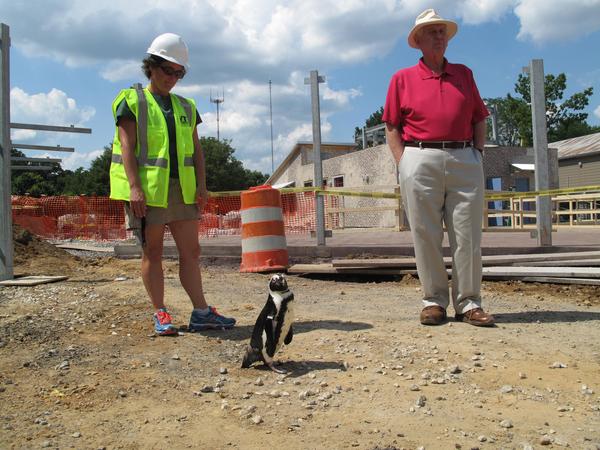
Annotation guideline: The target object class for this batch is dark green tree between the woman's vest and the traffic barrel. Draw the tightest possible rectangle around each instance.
[200,137,268,192]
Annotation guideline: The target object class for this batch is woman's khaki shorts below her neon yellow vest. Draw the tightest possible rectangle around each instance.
[125,178,200,245]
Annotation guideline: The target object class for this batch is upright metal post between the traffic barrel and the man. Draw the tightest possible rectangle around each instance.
[304,70,325,246]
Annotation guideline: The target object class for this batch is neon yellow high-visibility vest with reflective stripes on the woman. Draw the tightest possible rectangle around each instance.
[110,84,196,208]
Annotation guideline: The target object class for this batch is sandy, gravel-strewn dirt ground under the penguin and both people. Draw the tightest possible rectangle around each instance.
[0,229,600,450]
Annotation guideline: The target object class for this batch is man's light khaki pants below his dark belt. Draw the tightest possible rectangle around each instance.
[399,147,484,314]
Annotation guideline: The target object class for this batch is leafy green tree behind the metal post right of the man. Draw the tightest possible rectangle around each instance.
[485,73,600,146]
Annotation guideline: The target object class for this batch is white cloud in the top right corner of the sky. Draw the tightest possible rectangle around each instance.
[515,0,600,44]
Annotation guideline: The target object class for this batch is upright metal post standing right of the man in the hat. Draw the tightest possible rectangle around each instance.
[529,59,552,247]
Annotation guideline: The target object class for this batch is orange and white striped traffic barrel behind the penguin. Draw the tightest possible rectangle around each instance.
[240,185,288,272]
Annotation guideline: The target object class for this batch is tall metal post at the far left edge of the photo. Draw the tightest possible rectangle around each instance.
[0,24,13,280]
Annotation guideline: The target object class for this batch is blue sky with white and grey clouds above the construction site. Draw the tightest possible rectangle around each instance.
[0,0,600,173]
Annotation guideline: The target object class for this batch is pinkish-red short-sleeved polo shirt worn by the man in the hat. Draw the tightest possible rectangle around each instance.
[383,58,489,141]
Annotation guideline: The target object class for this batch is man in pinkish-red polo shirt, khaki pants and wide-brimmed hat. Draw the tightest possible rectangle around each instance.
[383,9,494,326]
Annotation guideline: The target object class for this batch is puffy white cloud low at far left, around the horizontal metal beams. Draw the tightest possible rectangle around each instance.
[10,87,96,140]
